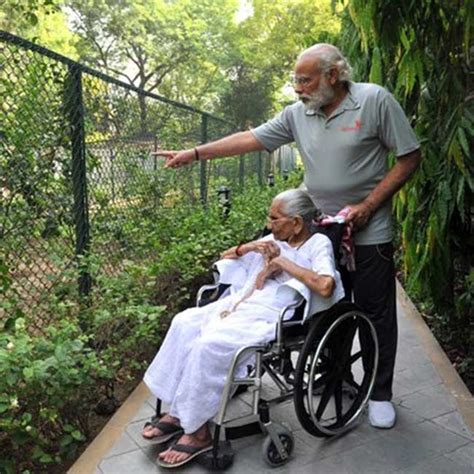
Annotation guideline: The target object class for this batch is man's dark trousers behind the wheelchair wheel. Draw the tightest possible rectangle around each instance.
[341,242,398,401]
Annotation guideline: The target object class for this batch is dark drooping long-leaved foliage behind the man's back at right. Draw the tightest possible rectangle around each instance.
[341,0,474,380]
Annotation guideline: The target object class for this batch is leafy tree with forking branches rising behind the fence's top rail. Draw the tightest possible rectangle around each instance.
[68,0,236,132]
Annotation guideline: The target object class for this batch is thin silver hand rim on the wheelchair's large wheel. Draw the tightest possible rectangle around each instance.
[307,311,378,436]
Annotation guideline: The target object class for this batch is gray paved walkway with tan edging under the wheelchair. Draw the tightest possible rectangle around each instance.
[70,284,474,474]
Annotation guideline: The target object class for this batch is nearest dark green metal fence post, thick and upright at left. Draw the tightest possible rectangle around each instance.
[65,65,91,296]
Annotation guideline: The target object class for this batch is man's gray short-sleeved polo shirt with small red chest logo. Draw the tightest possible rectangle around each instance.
[252,83,420,245]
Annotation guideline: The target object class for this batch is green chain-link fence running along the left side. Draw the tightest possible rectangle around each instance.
[0,32,295,328]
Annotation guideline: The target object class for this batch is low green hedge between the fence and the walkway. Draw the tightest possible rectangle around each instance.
[0,168,300,473]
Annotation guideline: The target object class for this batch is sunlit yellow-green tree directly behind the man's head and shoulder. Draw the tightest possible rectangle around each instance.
[221,0,340,127]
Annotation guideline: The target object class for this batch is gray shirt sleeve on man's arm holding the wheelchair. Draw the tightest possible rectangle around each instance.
[378,91,420,156]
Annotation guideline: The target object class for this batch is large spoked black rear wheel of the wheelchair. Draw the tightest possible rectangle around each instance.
[294,303,378,436]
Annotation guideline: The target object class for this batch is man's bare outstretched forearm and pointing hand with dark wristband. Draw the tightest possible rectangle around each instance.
[153,131,265,168]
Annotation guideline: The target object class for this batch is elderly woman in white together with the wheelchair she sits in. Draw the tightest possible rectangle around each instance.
[142,189,376,468]
